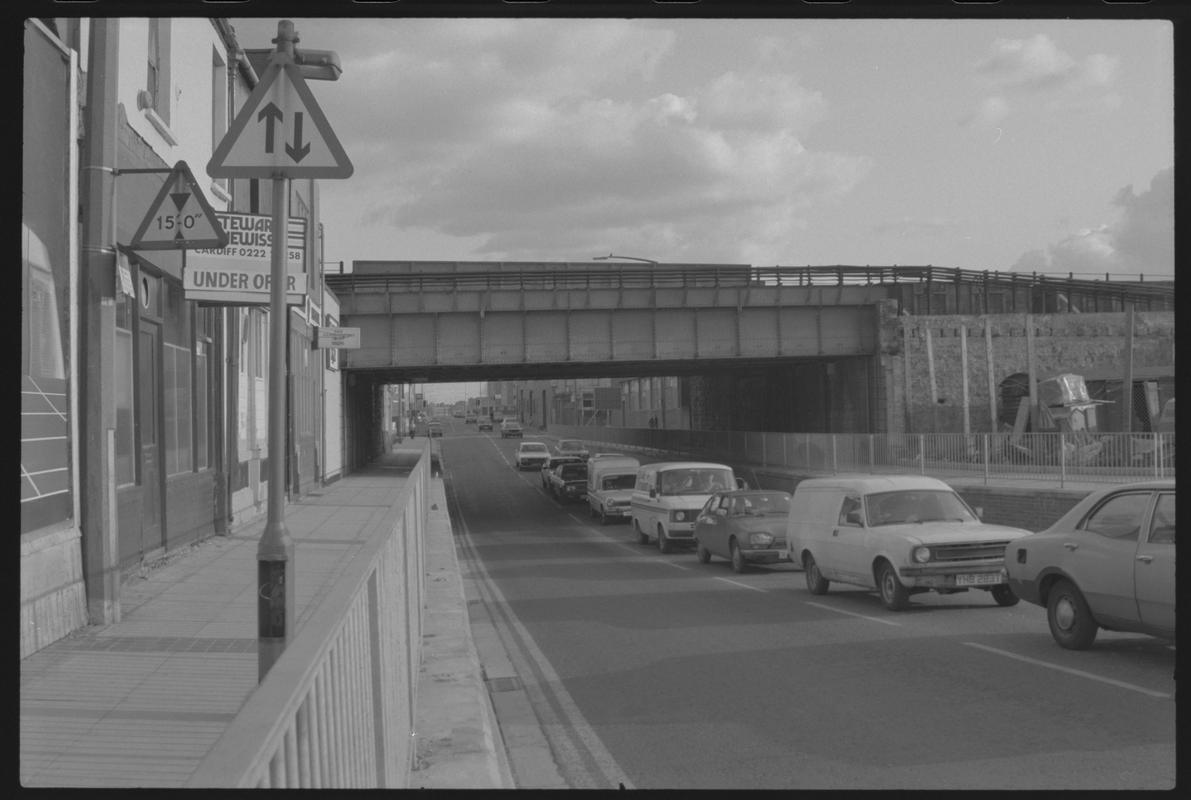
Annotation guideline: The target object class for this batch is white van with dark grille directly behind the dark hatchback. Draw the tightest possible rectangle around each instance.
[631,461,743,552]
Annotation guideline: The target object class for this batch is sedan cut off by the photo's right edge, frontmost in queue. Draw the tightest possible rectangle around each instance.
[1005,479,1176,650]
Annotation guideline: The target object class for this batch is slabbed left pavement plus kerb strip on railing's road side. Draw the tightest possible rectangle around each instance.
[19,442,516,789]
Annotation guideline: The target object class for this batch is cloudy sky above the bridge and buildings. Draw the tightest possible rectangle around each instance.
[231,17,1174,277]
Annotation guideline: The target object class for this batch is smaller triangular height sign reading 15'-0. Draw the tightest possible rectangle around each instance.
[131,161,227,250]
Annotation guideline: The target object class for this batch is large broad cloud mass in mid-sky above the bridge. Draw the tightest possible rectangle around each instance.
[326,20,871,262]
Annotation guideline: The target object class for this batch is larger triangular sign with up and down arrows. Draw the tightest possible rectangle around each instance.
[207,52,354,177]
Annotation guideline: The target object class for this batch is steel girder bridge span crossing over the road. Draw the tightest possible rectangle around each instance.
[324,261,890,463]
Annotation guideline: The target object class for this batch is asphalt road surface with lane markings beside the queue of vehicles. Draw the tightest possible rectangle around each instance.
[442,420,1176,789]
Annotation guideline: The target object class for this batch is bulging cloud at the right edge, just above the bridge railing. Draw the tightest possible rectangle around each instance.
[1012,167,1174,275]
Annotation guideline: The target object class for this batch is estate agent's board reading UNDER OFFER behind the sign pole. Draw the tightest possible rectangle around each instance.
[182,211,306,306]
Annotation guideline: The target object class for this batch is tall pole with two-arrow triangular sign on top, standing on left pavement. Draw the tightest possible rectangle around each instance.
[207,19,353,681]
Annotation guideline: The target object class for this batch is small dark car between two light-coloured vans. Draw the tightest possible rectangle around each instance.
[694,489,790,573]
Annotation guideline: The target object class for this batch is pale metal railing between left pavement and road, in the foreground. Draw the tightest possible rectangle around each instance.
[187,448,430,788]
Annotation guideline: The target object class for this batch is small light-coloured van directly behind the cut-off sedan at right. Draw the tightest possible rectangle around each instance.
[786,475,1030,611]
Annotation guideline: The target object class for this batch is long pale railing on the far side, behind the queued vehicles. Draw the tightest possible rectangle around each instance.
[550,425,1174,488]
